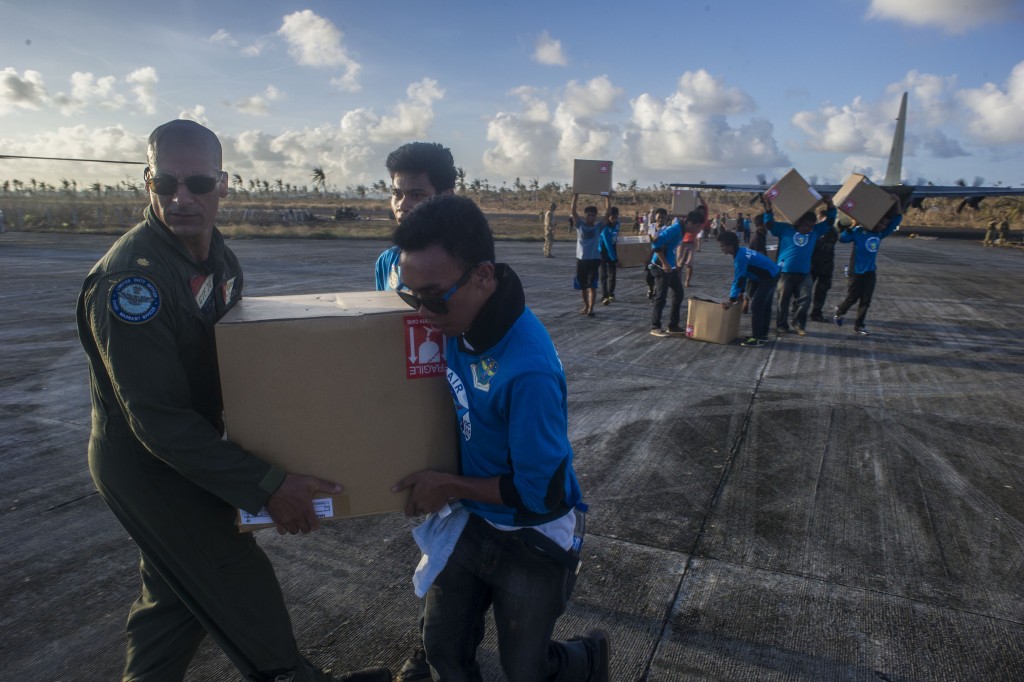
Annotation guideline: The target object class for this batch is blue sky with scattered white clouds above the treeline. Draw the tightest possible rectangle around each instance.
[0,0,1024,187]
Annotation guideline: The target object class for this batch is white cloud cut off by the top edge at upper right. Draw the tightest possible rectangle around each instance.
[867,0,1021,33]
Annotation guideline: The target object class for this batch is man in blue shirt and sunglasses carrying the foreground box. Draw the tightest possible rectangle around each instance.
[393,197,609,682]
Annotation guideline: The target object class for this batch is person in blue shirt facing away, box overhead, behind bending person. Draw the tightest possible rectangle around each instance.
[764,197,836,336]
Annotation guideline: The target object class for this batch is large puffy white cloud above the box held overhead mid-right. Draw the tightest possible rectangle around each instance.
[624,70,788,170]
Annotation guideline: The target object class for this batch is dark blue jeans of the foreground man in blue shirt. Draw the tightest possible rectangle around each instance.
[423,514,596,682]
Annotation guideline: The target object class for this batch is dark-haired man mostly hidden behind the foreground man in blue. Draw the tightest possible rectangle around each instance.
[374,142,458,291]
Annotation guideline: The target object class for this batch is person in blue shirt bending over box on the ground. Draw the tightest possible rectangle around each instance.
[718,231,779,348]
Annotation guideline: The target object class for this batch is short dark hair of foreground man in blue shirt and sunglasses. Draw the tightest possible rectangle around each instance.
[391,195,495,267]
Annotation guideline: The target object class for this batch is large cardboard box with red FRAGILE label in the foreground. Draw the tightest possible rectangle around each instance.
[215,292,458,516]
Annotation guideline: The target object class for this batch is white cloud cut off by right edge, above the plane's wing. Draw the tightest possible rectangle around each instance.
[956,61,1024,144]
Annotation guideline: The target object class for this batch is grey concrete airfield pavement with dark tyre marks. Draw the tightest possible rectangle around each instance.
[0,232,1024,682]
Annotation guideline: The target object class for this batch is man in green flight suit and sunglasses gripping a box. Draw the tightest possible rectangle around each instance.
[77,120,391,682]
